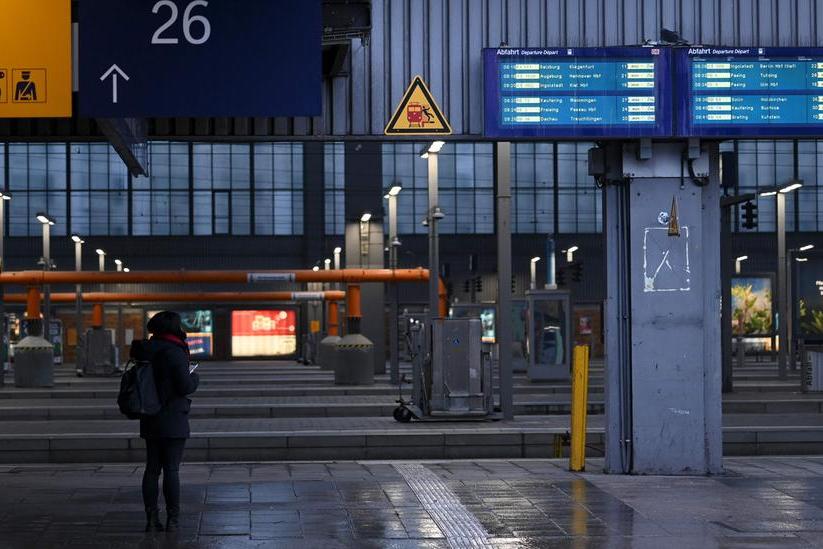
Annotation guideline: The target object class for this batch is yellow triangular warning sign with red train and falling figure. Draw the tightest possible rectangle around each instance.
[385,76,452,135]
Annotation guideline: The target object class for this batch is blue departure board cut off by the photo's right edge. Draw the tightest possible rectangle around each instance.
[675,47,823,137]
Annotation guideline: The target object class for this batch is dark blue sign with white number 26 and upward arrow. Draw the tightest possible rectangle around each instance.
[78,0,322,118]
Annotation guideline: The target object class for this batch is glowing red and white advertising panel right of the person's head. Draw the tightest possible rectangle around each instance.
[231,310,297,358]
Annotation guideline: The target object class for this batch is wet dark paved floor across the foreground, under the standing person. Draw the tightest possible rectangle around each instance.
[0,457,823,549]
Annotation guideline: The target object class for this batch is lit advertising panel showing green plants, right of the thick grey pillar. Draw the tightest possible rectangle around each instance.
[732,276,774,336]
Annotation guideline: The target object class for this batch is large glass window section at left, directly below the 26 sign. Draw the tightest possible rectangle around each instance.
[0,141,303,236]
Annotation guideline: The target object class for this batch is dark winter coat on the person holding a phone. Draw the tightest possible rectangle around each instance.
[140,338,200,438]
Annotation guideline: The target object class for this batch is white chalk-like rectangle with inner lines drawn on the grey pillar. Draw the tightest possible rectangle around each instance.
[643,227,691,292]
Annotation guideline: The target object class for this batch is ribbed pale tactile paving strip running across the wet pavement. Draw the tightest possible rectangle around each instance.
[394,463,494,549]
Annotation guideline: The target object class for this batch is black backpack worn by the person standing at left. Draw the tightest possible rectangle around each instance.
[117,339,163,419]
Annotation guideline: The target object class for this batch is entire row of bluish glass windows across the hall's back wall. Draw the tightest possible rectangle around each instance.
[0,140,823,236]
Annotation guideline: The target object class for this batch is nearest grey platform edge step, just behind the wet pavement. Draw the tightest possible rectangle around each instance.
[0,416,823,463]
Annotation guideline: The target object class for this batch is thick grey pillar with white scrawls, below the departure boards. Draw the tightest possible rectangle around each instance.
[604,143,722,474]
